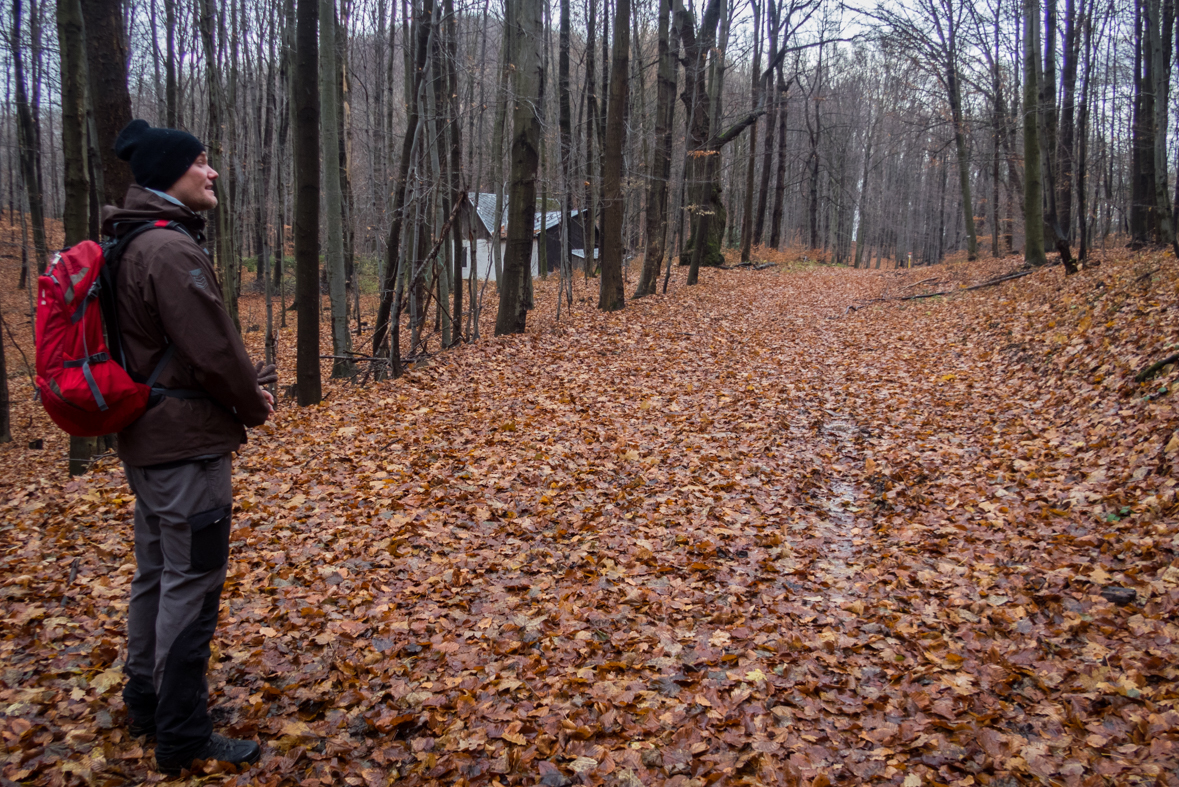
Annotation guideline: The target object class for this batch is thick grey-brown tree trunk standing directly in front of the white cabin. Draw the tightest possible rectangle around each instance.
[495,0,544,336]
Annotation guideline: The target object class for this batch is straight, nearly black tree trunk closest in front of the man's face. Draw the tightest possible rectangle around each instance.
[292,0,323,406]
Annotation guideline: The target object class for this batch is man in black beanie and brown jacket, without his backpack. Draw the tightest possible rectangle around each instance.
[103,120,277,773]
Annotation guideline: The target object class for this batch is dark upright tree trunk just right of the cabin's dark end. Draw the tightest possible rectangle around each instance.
[603,0,631,311]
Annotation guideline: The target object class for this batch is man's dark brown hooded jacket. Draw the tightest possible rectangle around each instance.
[103,185,268,467]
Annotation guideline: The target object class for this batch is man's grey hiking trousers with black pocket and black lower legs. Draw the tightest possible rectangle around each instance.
[123,454,233,761]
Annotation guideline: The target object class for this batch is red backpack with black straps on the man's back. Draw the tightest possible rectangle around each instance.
[37,220,187,437]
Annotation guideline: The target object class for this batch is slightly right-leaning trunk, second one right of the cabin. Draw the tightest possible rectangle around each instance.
[634,0,676,298]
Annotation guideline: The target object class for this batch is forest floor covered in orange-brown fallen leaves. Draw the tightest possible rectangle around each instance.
[0,241,1179,787]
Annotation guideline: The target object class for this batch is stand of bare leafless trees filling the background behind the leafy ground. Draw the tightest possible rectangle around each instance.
[9,0,1179,464]
